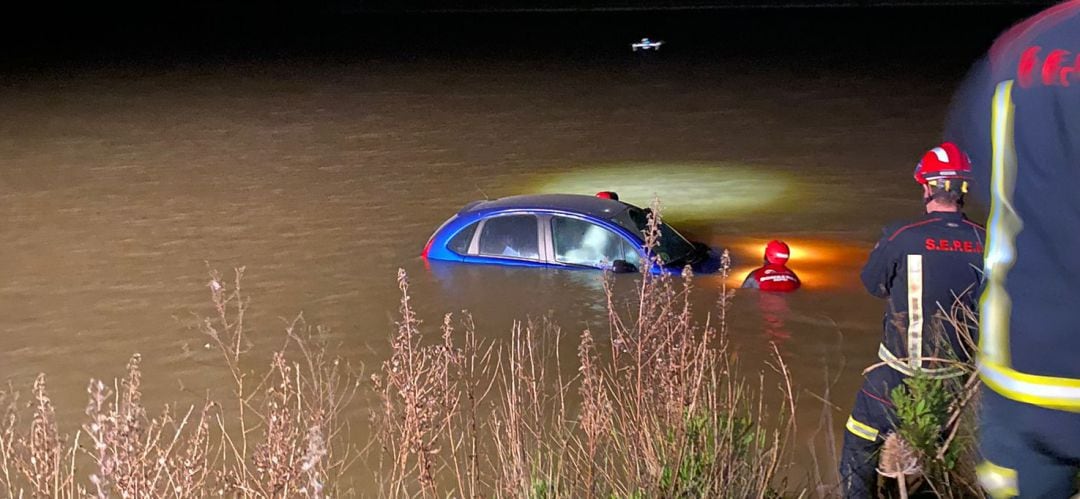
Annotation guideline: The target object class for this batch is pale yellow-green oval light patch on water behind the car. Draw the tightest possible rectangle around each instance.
[535,163,791,221]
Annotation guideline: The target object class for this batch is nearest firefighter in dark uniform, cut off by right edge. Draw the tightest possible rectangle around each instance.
[946,0,1080,498]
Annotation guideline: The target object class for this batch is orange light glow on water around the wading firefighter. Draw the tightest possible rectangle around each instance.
[714,235,870,289]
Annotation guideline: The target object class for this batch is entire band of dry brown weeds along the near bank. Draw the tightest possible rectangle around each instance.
[0,204,812,499]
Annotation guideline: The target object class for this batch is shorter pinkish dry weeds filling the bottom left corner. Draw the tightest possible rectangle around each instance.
[0,268,360,498]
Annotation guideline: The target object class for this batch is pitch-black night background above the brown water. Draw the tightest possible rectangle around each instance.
[0,0,1047,69]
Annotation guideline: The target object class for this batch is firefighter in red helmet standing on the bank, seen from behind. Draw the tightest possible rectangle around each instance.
[840,143,986,498]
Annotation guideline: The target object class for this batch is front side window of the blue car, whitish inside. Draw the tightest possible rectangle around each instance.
[551,217,638,268]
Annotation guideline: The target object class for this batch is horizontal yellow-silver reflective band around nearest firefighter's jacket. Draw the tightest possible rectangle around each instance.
[978,359,1080,413]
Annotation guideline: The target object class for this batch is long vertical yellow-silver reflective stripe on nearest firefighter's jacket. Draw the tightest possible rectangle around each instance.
[978,80,1023,365]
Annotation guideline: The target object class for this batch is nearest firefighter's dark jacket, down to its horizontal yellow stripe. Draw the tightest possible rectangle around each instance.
[950,1,1080,401]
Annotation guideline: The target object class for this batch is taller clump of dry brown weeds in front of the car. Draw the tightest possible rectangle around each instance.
[373,205,795,498]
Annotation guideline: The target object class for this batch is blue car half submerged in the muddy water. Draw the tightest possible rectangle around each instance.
[423,194,719,273]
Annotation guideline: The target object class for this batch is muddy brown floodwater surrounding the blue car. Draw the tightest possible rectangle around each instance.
[0,54,984,488]
